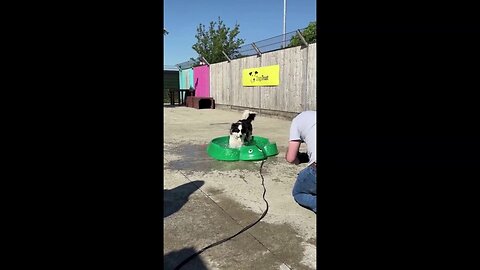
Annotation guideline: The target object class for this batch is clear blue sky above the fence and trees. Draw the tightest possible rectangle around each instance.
[163,0,317,65]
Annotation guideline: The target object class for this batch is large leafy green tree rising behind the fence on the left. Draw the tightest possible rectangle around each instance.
[192,17,244,64]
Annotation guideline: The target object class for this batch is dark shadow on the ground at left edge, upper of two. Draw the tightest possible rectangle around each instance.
[163,180,205,218]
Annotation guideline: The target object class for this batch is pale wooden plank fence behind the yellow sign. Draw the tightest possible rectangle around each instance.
[210,43,317,113]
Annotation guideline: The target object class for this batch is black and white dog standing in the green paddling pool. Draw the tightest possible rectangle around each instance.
[228,110,257,148]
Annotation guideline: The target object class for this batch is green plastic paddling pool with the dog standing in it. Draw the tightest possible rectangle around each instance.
[207,136,278,161]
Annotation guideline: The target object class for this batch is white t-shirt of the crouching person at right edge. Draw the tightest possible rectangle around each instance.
[290,111,317,165]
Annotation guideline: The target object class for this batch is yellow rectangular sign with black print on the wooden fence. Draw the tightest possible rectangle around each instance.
[242,65,280,86]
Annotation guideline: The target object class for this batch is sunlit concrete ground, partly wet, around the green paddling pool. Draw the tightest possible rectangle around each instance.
[163,107,317,270]
